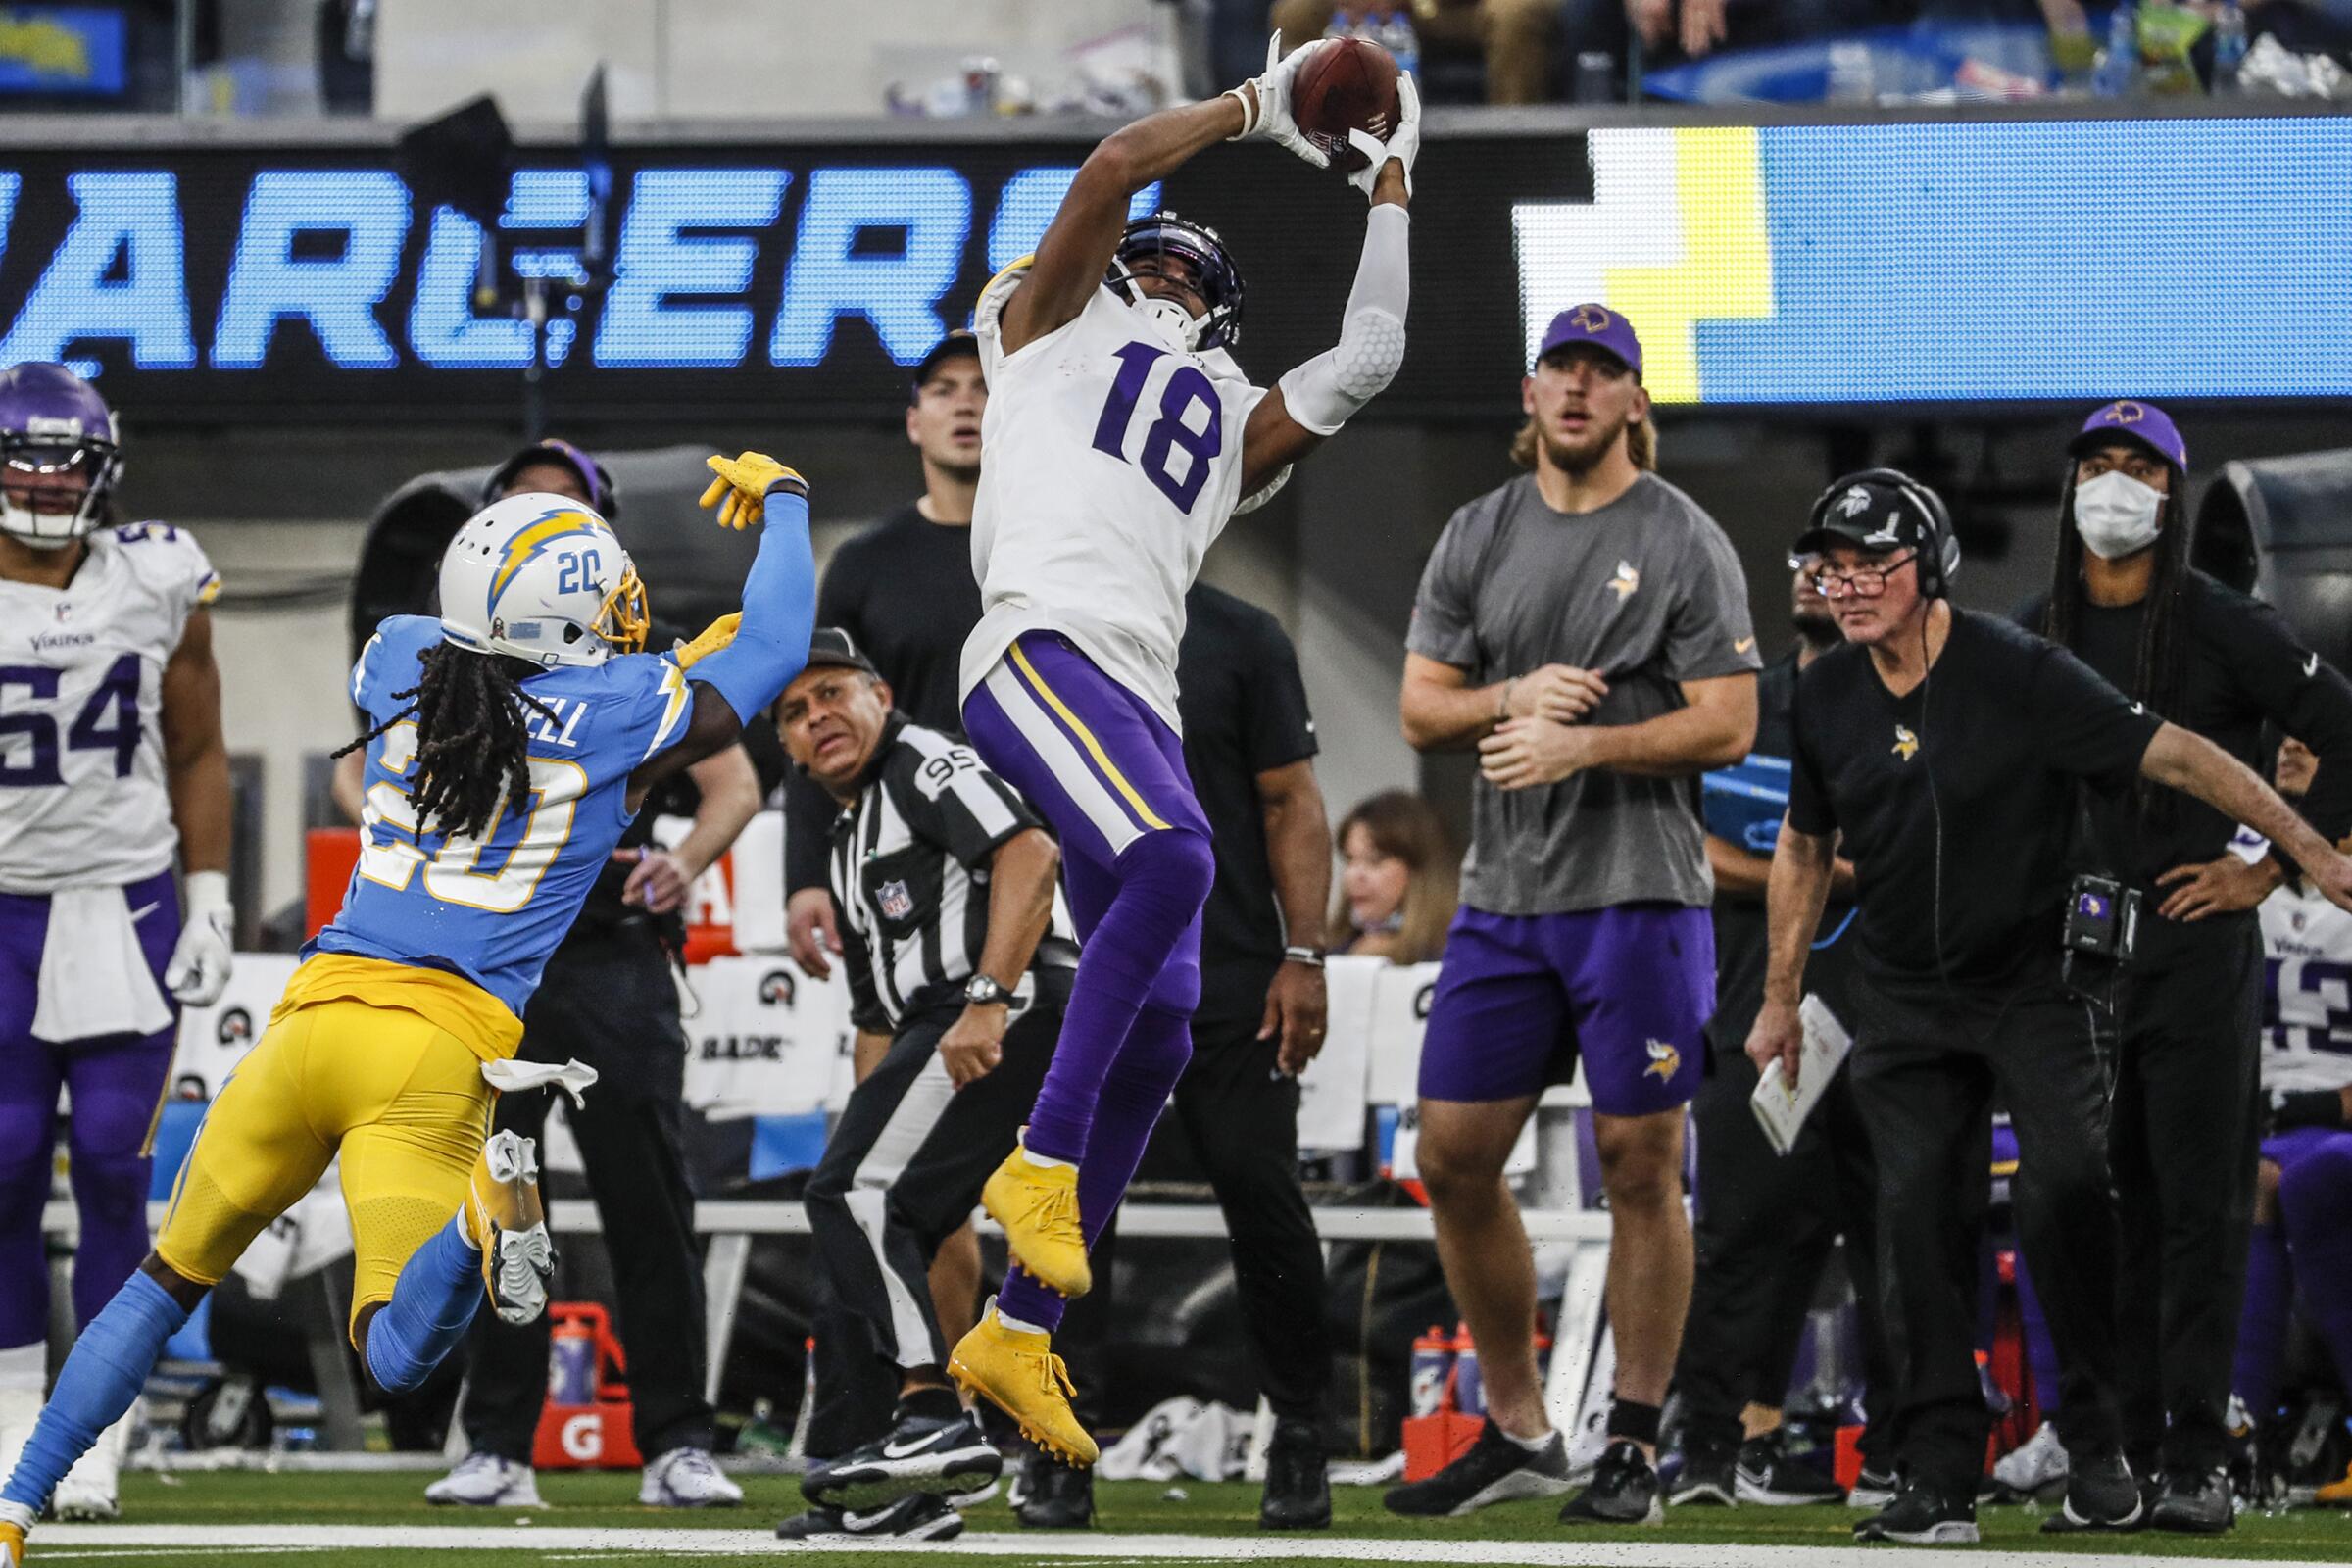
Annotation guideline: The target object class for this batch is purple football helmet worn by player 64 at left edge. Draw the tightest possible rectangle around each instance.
[0,360,122,550]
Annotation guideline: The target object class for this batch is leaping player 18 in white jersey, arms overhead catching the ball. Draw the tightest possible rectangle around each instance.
[951,42,1421,1464]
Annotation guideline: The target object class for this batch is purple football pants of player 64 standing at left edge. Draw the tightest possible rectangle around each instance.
[0,872,178,1349]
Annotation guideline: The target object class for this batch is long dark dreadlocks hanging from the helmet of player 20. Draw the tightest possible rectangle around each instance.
[336,642,555,839]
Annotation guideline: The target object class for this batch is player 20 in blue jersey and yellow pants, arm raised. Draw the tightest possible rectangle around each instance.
[0,454,816,1568]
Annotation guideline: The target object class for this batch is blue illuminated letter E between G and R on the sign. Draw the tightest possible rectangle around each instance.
[595,170,790,367]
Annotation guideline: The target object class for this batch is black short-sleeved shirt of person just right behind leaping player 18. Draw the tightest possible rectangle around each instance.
[1176,583,1317,1022]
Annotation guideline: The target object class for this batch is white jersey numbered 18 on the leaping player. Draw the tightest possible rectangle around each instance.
[962,270,1265,731]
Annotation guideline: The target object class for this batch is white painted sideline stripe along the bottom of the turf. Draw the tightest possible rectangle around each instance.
[35,1523,2319,1568]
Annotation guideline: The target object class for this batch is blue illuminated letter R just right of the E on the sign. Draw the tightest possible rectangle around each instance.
[766,170,971,365]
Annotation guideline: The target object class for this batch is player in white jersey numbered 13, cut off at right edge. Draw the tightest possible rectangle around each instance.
[2232,741,2352,1504]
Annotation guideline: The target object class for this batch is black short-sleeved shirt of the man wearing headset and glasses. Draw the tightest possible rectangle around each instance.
[1788,609,2164,987]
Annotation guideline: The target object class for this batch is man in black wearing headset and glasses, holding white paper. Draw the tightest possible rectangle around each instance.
[1747,467,2352,1544]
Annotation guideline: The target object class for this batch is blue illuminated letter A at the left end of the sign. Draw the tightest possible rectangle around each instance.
[0,174,195,369]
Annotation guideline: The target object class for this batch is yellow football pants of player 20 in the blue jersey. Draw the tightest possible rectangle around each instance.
[155,1002,496,1343]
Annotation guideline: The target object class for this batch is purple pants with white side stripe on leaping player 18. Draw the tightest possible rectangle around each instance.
[964,632,1216,1328]
